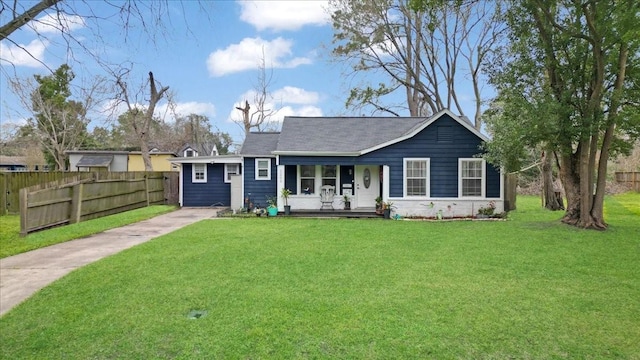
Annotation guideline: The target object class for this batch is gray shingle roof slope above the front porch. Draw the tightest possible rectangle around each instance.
[274,117,428,153]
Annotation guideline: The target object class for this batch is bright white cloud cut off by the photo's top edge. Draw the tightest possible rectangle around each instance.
[238,0,330,31]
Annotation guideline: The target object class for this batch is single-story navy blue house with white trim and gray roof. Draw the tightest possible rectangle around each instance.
[172,110,504,216]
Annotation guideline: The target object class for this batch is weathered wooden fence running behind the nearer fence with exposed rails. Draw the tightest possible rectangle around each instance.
[0,171,179,216]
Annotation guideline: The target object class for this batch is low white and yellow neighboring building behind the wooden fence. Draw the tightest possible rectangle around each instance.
[66,150,178,172]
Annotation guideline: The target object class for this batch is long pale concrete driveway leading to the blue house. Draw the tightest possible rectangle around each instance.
[0,208,217,315]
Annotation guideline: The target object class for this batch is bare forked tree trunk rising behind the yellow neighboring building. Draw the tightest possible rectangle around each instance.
[116,71,169,171]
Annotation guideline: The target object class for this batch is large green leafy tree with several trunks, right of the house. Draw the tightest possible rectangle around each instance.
[490,0,640,229]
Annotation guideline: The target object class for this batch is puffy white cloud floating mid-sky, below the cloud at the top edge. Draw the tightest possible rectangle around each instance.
[207,37,311,76]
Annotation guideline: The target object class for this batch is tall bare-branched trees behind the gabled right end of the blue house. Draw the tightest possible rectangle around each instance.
[331,0,502,128]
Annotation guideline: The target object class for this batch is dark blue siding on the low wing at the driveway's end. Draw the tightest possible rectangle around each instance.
[182,164,231,206]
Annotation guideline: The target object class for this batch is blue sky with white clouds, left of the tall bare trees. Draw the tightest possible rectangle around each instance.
[0,1,480,148]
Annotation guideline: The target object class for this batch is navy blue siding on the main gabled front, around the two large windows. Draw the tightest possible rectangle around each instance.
[280,115,500,198]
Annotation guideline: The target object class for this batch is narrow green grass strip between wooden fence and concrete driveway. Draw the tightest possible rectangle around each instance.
[0,205,176,259]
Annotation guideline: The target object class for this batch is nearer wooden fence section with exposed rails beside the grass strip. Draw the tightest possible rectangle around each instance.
[20,173,176,235]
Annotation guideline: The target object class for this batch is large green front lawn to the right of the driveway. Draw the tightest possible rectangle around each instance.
[0,194,640,359]
